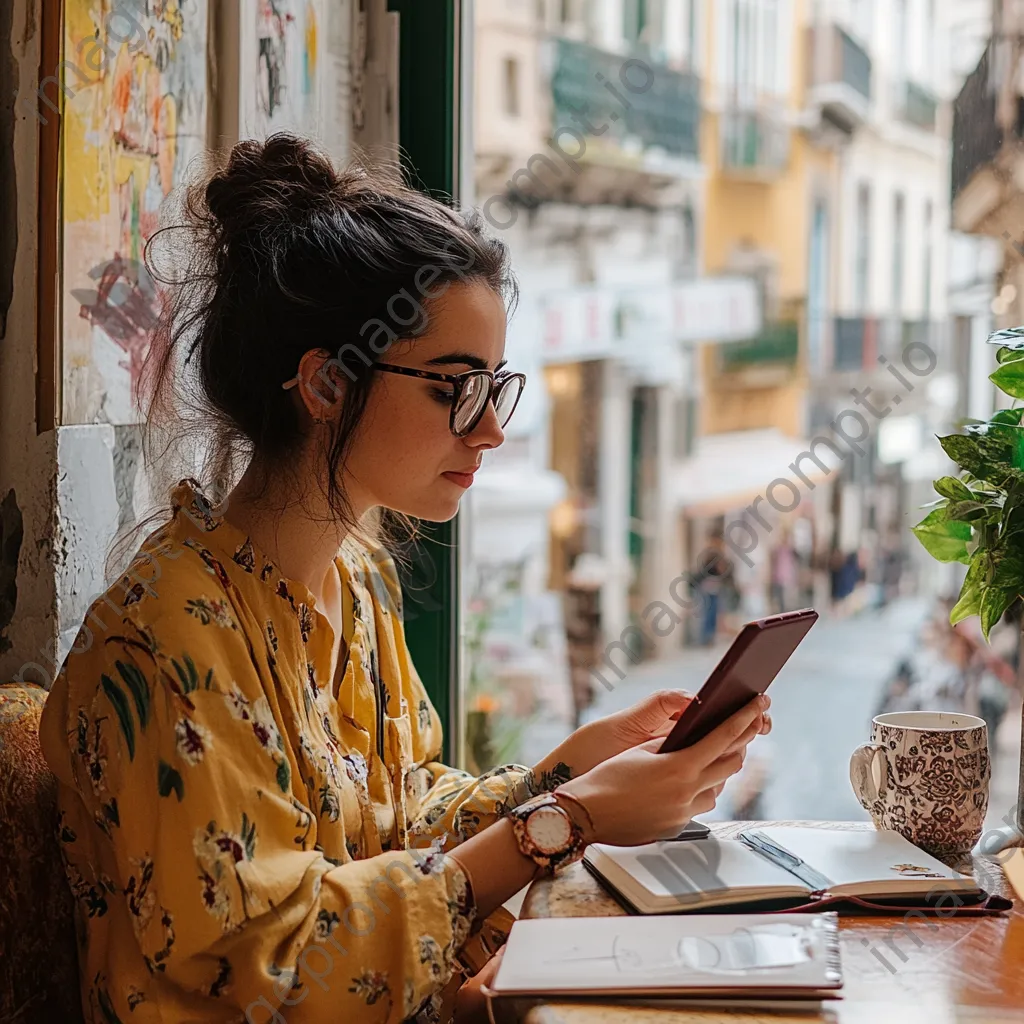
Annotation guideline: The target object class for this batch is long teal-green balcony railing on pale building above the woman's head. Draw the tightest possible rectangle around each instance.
[551,39,700,160]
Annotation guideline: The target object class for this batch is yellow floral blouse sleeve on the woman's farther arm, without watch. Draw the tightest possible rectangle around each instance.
[364,549,569,850]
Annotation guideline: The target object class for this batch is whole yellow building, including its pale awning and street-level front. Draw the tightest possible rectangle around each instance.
[677,0,847,622]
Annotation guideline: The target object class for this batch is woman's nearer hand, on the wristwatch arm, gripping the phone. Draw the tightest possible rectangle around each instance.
[555,696,771,846]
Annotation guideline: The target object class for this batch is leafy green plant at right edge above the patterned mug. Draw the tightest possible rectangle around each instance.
[913,327,1024,852]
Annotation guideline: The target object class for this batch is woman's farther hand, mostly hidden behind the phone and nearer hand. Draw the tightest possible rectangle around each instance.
[534,690,693,778]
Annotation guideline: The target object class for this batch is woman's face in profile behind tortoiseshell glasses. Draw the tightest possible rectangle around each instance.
[337,282,506,522]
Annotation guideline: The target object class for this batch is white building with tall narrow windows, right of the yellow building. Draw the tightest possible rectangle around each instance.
[813,0,966,581]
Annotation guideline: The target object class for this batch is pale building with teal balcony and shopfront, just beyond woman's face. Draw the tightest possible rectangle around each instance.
[466,0,760,737]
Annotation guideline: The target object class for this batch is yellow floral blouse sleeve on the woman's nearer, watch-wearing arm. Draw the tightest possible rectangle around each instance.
[47,606,475,1024]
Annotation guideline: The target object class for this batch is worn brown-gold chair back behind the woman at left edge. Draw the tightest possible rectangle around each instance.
[0,683,84,1024]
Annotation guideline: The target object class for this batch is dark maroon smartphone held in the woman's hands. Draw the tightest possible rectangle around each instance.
[657,608,818,754]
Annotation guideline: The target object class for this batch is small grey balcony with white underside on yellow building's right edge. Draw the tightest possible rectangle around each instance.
[807,23,871,132]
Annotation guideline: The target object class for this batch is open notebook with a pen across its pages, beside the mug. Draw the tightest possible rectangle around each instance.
[584,825,983,913]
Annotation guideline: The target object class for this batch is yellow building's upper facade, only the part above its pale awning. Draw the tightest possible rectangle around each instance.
[700,0,838,438]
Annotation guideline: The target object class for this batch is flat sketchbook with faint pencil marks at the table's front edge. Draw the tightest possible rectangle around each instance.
[490,913,843,1008]
